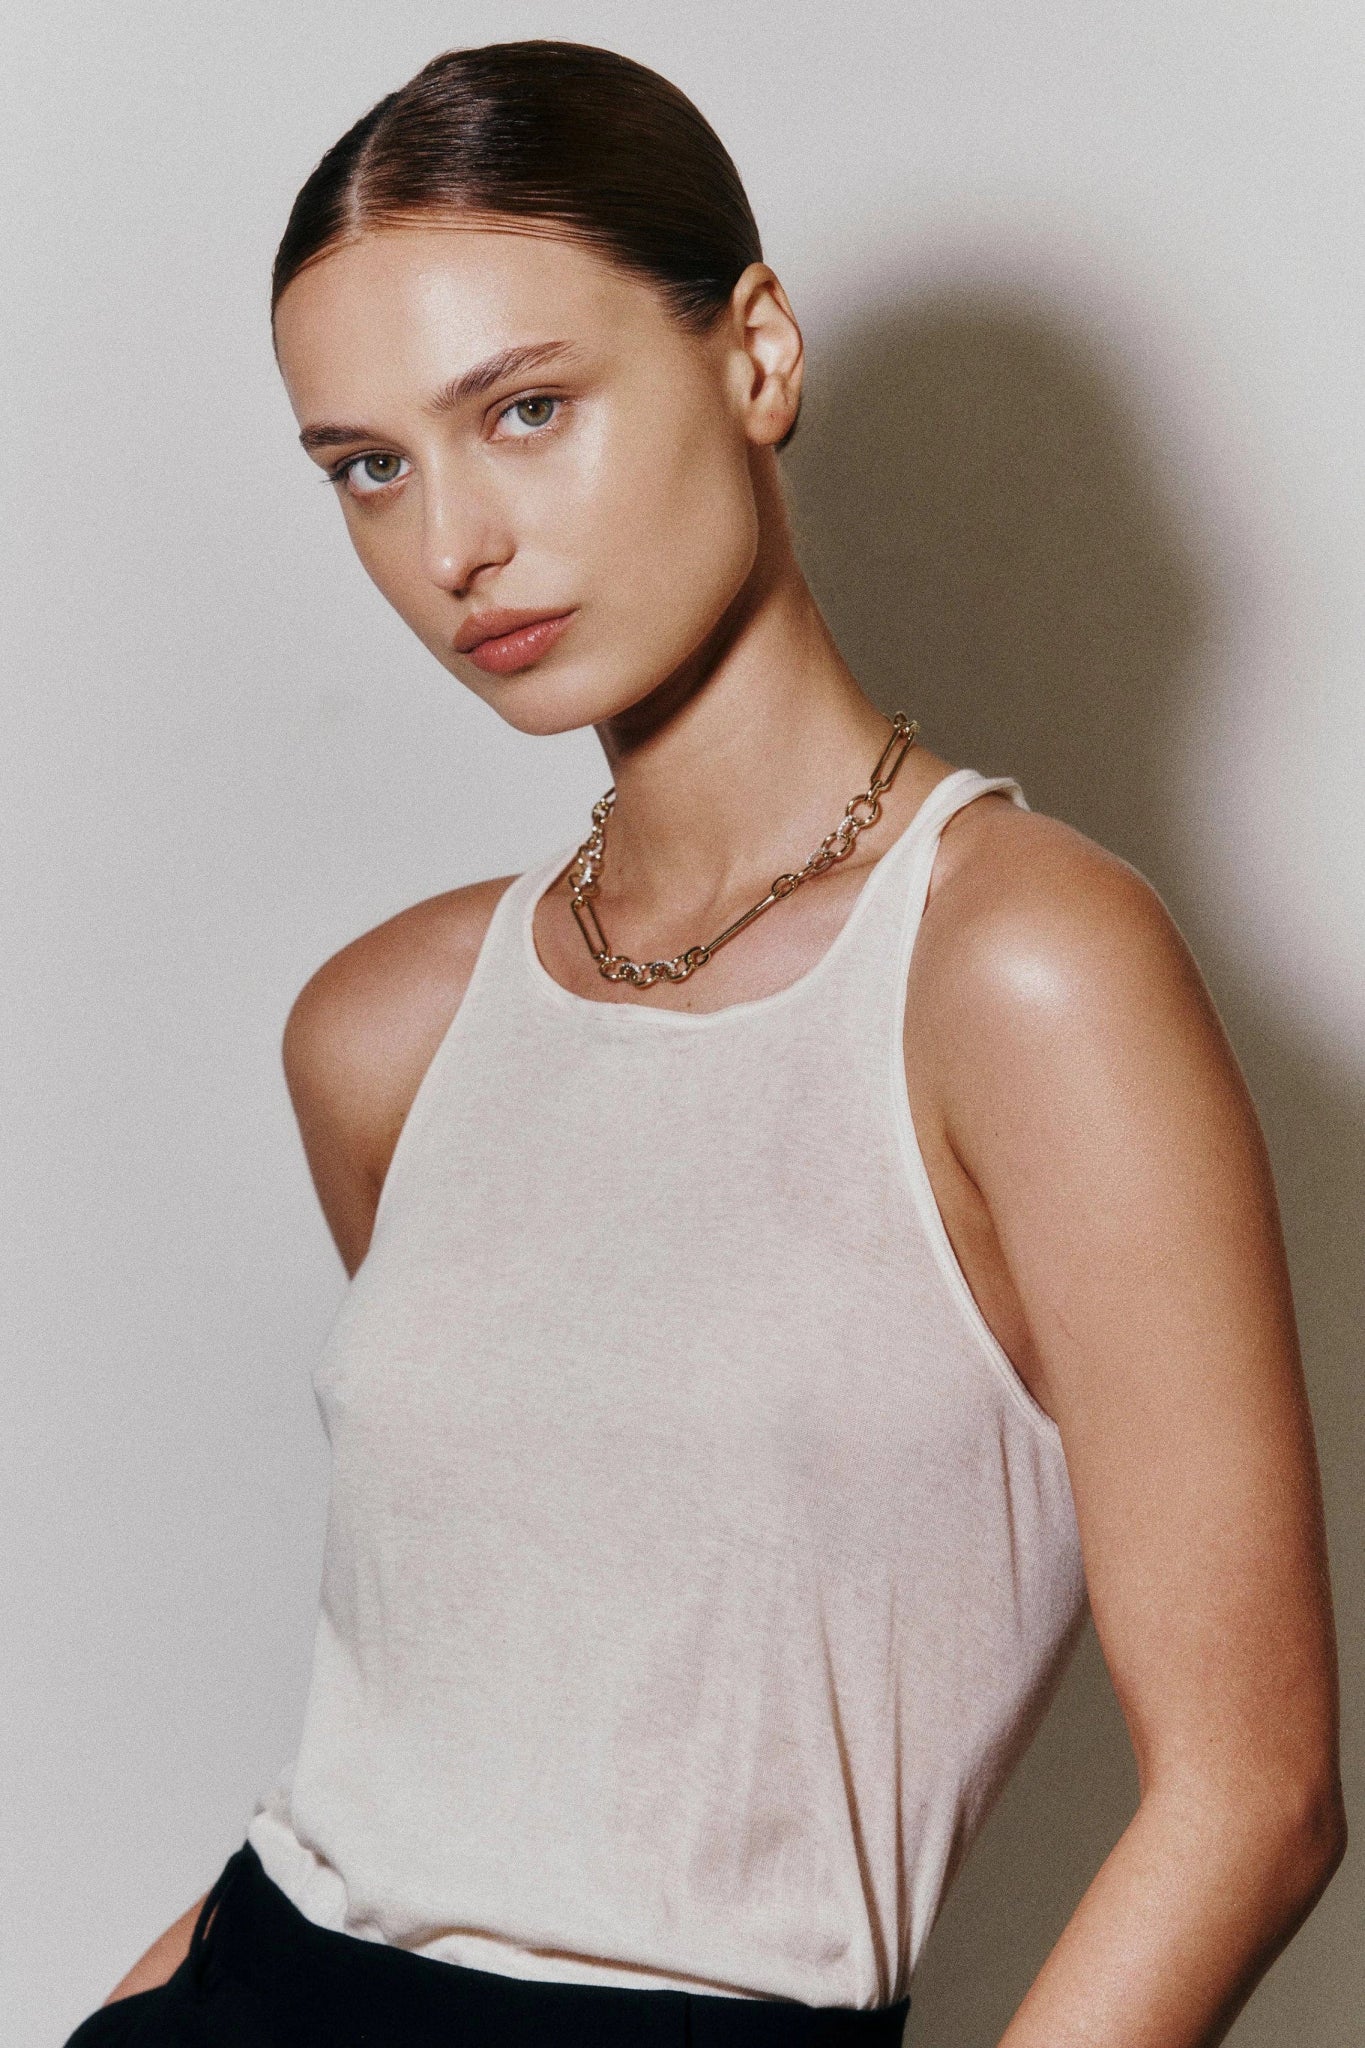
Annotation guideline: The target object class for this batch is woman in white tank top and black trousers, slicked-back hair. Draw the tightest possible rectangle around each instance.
[74,43,1342,2048]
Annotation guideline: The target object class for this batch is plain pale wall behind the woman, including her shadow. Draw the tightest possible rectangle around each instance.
[0,0,1365,2048]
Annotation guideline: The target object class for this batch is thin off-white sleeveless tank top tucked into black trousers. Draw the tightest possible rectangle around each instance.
[248,768,1085,2007]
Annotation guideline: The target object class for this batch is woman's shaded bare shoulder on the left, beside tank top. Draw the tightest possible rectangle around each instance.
[284,877,510,1274]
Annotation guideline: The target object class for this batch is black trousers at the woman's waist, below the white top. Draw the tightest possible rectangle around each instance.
[68,1843,911,2048]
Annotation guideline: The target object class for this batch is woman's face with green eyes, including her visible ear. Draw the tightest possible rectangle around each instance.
[274,223,800,733]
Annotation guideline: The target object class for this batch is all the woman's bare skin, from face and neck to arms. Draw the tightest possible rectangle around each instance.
[104,219,1345,2048]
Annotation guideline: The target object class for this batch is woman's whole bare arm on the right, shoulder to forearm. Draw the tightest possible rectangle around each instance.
[915,805,1345,2048]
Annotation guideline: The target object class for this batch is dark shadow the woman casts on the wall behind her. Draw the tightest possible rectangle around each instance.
[786,293,1365,2048]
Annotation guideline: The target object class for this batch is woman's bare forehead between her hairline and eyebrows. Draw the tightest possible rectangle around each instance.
[274,223,673,410]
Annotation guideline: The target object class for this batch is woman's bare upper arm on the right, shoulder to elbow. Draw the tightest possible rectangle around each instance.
[925,813,1336,1826]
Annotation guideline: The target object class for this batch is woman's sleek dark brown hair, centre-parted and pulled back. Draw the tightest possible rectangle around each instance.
[270,41,763,332]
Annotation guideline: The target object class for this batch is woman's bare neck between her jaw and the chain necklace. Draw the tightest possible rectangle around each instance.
[598,477,913,907]
